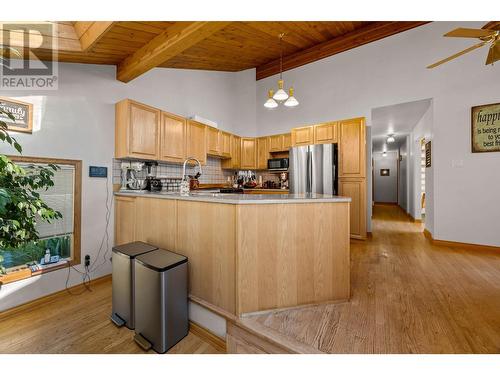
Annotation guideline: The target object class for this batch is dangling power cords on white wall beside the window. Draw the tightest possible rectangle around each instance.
[66,174,113,295]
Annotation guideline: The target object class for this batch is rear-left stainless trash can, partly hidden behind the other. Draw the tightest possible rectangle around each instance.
[111,241,158,329]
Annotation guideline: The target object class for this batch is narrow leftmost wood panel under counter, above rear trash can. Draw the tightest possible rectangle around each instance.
[115,196,136,246]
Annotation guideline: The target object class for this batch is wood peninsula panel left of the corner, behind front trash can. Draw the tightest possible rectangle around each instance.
[175,201,236,314]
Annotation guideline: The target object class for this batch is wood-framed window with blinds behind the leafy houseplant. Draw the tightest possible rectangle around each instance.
[0,156,81,282]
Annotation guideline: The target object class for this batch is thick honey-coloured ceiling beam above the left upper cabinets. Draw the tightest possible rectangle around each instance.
[116,21,231,82]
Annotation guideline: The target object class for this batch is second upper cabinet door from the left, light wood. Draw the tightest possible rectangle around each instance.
[160,112,186,163]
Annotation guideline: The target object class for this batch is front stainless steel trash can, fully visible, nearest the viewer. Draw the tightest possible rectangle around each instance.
[134,249,189,353]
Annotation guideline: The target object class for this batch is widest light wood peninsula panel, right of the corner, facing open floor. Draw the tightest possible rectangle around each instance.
[236,203,350,315]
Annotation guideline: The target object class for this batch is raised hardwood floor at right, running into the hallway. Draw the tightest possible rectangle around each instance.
[241,205,500,353]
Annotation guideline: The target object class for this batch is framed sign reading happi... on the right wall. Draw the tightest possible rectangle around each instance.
[471,103,500,152]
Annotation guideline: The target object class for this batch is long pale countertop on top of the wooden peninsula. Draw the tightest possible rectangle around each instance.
[115,190,351,204]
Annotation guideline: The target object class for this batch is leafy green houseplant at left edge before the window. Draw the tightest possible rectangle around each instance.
[0,109,62,273]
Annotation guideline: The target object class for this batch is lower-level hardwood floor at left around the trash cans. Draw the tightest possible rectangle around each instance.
[0,280,225,354]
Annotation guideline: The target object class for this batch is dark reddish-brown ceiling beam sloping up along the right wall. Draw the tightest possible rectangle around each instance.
[256,21,428,80]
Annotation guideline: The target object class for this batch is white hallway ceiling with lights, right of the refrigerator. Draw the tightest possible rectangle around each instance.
[371,99,431,152]
